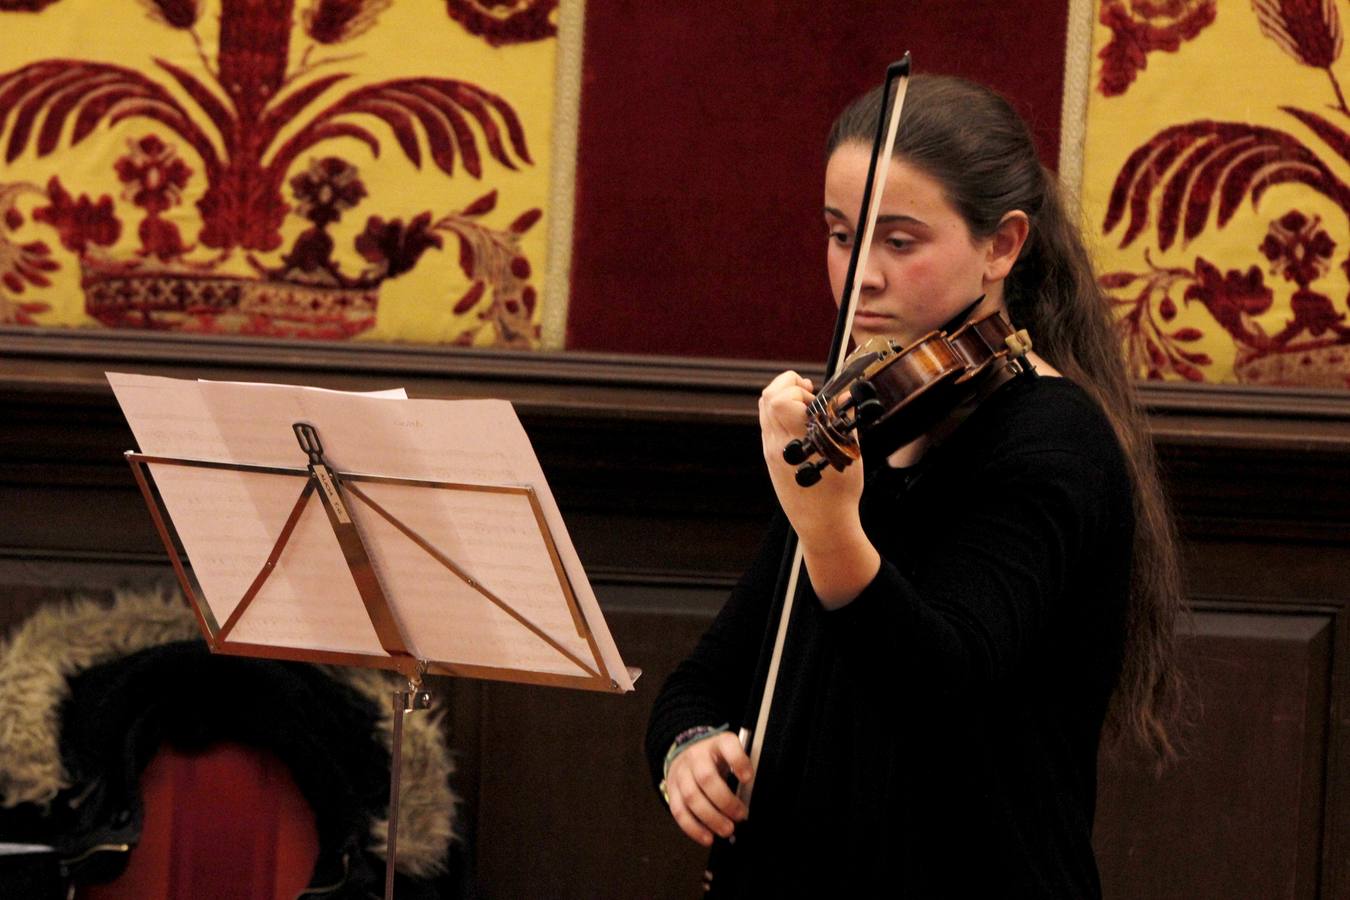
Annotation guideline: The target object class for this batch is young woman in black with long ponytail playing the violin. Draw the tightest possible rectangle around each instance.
[647,76,1180,899]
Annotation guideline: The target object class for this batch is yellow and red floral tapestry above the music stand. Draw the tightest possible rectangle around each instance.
[0,0,566,347]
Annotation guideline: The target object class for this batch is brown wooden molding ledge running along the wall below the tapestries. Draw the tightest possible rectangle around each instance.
[0,327,1350,439]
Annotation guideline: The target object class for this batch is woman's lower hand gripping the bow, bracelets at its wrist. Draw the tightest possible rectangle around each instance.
[666,731,755,847]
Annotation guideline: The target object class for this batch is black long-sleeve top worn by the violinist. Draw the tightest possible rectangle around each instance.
[647,378,1134,899]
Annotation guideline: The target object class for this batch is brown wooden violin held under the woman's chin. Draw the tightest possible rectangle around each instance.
[783,297,1033,487]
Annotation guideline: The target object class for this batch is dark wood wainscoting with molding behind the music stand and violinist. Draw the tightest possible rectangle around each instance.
[0,334,1350,900]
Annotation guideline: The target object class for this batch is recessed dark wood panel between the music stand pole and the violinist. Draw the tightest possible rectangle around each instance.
[478,599,707,900]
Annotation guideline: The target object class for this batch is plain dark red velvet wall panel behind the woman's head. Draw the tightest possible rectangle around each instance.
[567,0,1068,362]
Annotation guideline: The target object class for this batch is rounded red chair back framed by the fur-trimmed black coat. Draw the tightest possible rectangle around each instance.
[78,743,319,900]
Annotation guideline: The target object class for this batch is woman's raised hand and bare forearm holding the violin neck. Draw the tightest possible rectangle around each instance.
[759,371,880,606]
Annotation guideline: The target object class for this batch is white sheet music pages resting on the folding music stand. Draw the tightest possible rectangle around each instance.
[108,372,633,691]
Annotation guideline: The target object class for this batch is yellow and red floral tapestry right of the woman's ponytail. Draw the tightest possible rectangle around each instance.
[1083,0,1350,387]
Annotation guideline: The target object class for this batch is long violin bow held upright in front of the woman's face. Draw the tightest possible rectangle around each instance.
[703,59,910,895]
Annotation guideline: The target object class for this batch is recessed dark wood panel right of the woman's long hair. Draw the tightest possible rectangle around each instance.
[1095,610,1334,900]
